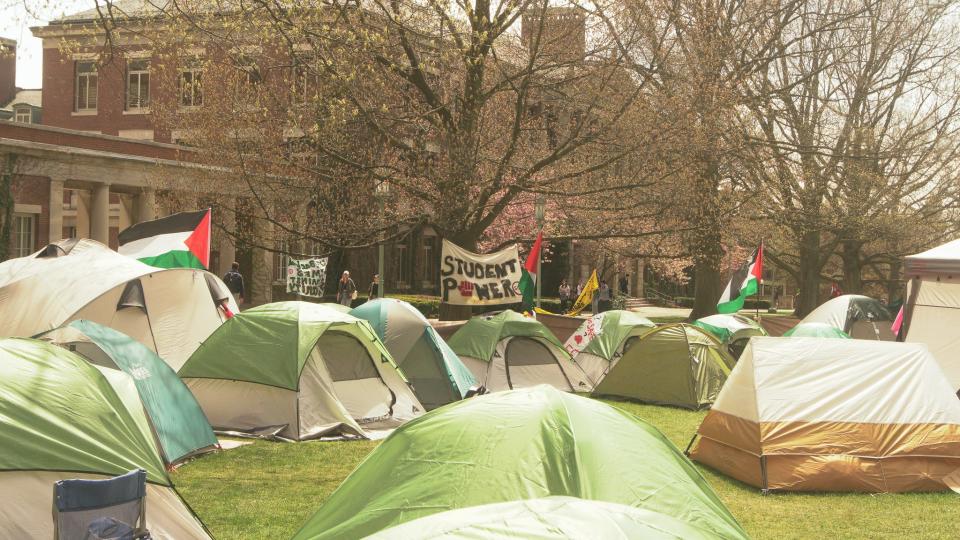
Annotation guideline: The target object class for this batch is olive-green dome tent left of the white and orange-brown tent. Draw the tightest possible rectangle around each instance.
[593,323,736,409]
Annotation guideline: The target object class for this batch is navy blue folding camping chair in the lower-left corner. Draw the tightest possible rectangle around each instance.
[53,469,150,540]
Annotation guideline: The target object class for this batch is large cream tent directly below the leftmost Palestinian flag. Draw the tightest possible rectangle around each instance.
[0,240,238,370]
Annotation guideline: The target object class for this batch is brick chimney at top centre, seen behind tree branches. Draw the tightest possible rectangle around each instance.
[520,7,587,62]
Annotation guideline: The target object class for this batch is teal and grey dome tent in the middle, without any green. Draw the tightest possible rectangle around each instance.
[350,298,477,411]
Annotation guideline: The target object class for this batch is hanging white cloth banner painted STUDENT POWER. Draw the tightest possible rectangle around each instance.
[440,240,522,305]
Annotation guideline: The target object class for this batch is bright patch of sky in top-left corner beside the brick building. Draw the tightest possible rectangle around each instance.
[0,0,89,88]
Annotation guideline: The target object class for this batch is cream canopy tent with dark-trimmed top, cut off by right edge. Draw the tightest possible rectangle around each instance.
[900,240,960,391]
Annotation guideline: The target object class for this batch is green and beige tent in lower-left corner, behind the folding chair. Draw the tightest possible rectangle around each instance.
[0,338,208,538]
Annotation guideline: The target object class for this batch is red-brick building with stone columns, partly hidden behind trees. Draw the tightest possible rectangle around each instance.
[9,0,636,308]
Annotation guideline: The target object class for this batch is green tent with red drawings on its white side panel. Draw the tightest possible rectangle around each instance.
[564,309,657,388]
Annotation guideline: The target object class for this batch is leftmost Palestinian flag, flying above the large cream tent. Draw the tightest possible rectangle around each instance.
[118,208,210,269]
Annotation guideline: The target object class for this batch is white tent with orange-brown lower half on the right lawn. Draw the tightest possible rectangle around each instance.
[690,337,960,492]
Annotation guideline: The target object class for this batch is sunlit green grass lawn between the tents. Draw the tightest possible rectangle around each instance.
[174,402,960,540]
